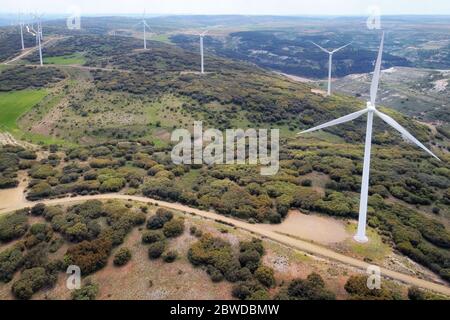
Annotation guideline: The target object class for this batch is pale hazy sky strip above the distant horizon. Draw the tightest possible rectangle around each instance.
[0,0,450,15]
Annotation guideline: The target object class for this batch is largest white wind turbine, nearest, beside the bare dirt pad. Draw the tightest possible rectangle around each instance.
[300,33,440,243]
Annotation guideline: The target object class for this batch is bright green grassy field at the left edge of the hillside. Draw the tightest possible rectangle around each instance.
[0,89,47,134]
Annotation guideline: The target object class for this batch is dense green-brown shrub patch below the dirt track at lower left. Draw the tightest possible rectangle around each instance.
[0,201,146,299]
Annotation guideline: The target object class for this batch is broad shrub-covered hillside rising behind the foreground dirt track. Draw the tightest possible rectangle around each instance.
[0,21,450,298]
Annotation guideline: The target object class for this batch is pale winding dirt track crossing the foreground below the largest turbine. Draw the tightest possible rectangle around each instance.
[0,194,450,296]
